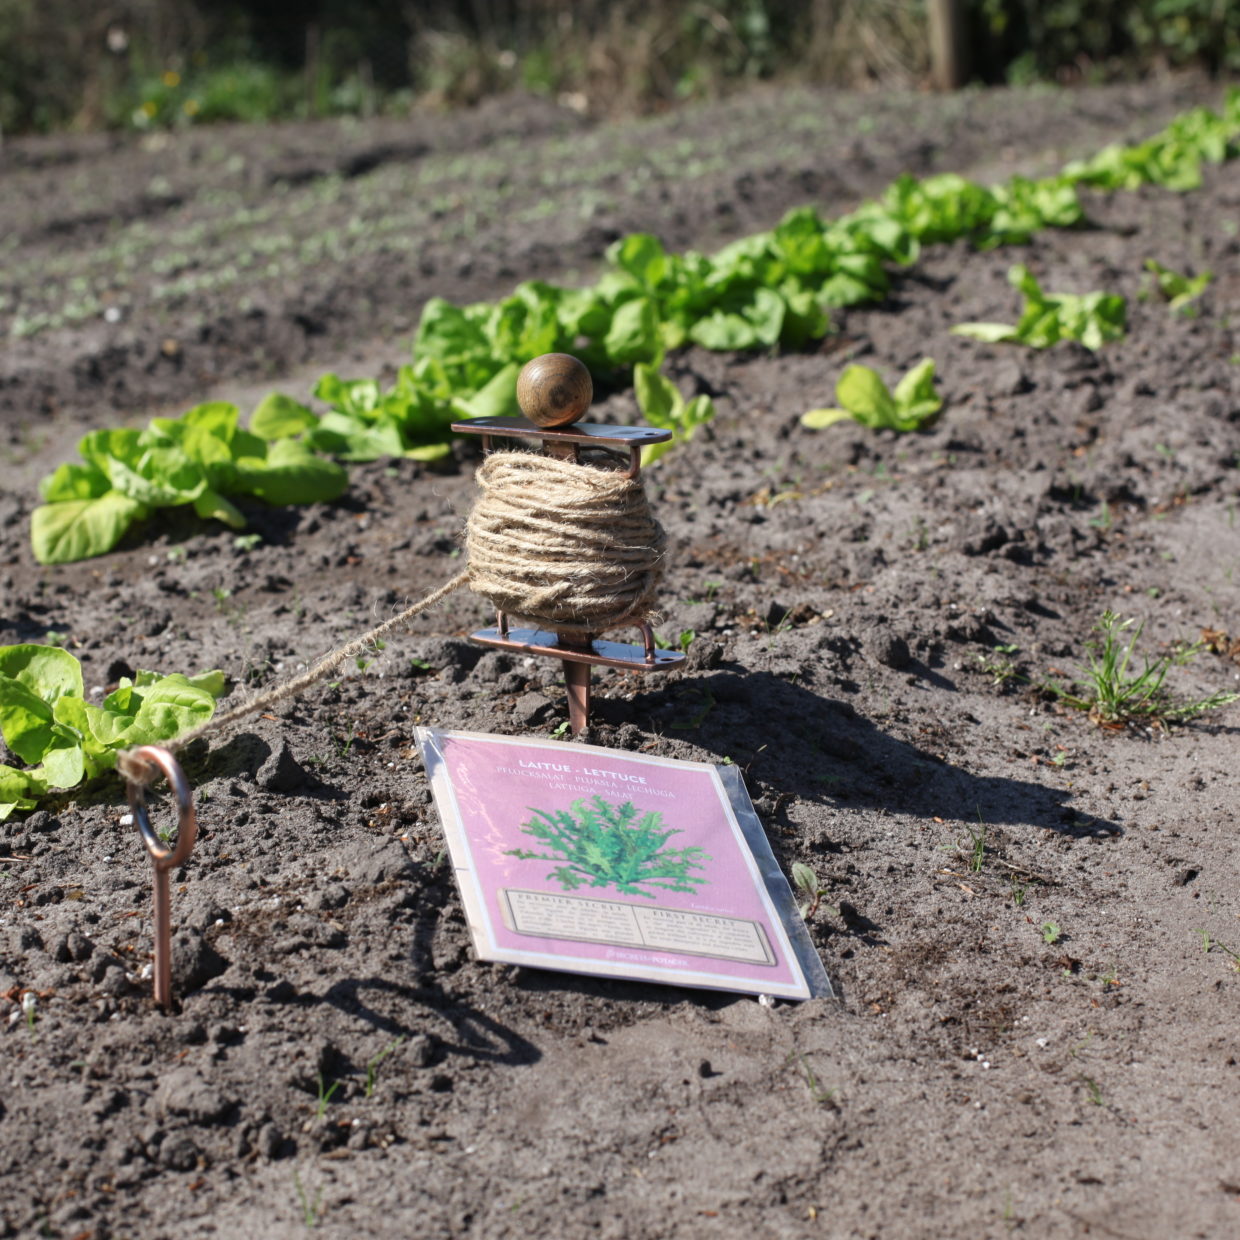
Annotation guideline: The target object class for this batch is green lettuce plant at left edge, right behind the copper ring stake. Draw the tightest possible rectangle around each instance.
[0,645,224,821]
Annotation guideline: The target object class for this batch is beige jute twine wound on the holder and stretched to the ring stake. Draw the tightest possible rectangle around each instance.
[117,451,667,785]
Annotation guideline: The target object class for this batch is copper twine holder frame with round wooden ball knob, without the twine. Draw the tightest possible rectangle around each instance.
[451,353,684,737]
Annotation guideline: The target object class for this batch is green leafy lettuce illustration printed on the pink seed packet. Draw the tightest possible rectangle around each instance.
[507,796,711,900]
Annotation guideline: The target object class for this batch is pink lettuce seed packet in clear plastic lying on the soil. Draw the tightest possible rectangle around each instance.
[415,728,831,999]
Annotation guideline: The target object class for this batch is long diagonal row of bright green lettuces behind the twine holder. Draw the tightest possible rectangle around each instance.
[31,89,1240,564]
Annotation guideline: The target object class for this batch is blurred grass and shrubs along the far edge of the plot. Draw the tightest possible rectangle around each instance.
[0,0,1240,134]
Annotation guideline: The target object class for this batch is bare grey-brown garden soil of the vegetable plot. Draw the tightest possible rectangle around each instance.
[0,79,1240,1240]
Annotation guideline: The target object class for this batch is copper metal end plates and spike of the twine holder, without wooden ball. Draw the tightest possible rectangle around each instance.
[453,418,684,737]
